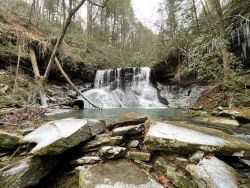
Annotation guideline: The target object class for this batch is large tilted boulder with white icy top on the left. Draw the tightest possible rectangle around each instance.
[21,118,105,155]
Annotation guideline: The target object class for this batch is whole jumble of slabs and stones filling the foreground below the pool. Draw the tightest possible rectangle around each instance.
[0,117,250,188]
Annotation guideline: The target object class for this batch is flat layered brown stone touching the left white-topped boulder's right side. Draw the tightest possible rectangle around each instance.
[80,134,125,152]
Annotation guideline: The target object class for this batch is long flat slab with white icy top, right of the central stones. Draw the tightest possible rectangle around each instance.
[144,122,250,157]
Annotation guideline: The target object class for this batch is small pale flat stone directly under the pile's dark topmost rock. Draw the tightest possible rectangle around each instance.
[112,124,144,136]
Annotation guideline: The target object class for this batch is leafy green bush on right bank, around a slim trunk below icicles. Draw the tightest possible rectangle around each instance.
[185,39,242,88]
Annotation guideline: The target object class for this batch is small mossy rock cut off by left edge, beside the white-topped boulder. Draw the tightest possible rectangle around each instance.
[0,130,22,149]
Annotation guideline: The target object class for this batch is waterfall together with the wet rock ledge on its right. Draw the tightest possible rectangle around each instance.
[80,67,211,108]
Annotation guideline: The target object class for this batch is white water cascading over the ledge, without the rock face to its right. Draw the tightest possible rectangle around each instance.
[84,67,165,108]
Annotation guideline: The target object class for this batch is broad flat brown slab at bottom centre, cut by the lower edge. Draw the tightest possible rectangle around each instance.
[78,159,163,188]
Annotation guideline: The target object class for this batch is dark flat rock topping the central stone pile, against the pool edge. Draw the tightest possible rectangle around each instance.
[107,116,147,129]
